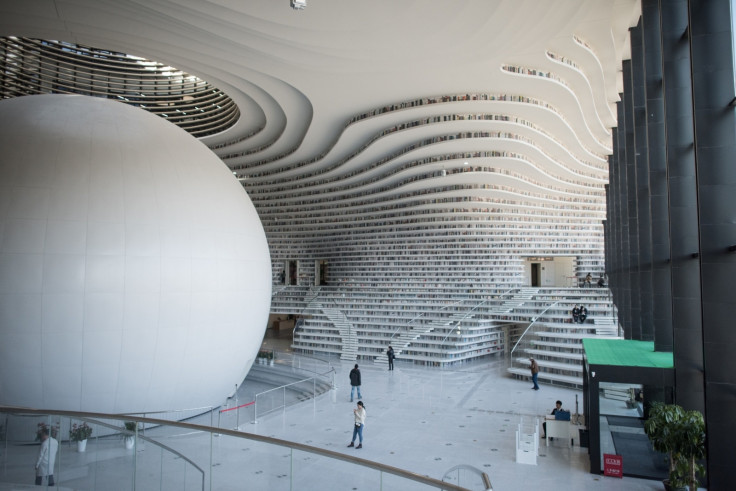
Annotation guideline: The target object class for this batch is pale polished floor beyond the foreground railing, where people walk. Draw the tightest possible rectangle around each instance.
[252,336,662,491]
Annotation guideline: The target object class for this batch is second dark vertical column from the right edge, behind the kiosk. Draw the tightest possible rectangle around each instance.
[662,0,703,409]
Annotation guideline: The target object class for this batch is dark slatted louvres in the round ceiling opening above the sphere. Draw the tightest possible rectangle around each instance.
[0,36,240,137]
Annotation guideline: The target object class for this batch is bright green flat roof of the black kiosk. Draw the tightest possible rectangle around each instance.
[583,338,675,368]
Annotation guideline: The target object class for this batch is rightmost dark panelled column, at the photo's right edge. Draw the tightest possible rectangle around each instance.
[688,0,736,489]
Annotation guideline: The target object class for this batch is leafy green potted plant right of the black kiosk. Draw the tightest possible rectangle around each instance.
[644,402,705,491]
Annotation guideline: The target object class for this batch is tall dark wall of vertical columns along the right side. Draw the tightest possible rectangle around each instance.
[605,0,736,489]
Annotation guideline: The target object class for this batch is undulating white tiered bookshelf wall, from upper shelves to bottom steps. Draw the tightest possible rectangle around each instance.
[250,53,616,372]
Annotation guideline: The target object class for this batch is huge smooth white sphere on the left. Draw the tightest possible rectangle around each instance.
[0,95,271,413]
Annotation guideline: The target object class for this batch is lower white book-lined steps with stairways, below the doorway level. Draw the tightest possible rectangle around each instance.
[272,286,617,372]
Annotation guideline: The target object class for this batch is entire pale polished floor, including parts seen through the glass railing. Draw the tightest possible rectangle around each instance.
[0,333,662,491]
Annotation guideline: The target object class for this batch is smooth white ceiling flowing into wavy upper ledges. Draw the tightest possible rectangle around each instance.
[0,0,640,254]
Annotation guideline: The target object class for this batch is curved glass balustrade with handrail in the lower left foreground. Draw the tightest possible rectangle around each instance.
[0,406,467,491]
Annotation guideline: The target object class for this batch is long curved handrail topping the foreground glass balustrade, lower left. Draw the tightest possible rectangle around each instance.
[0,406,470,491]
